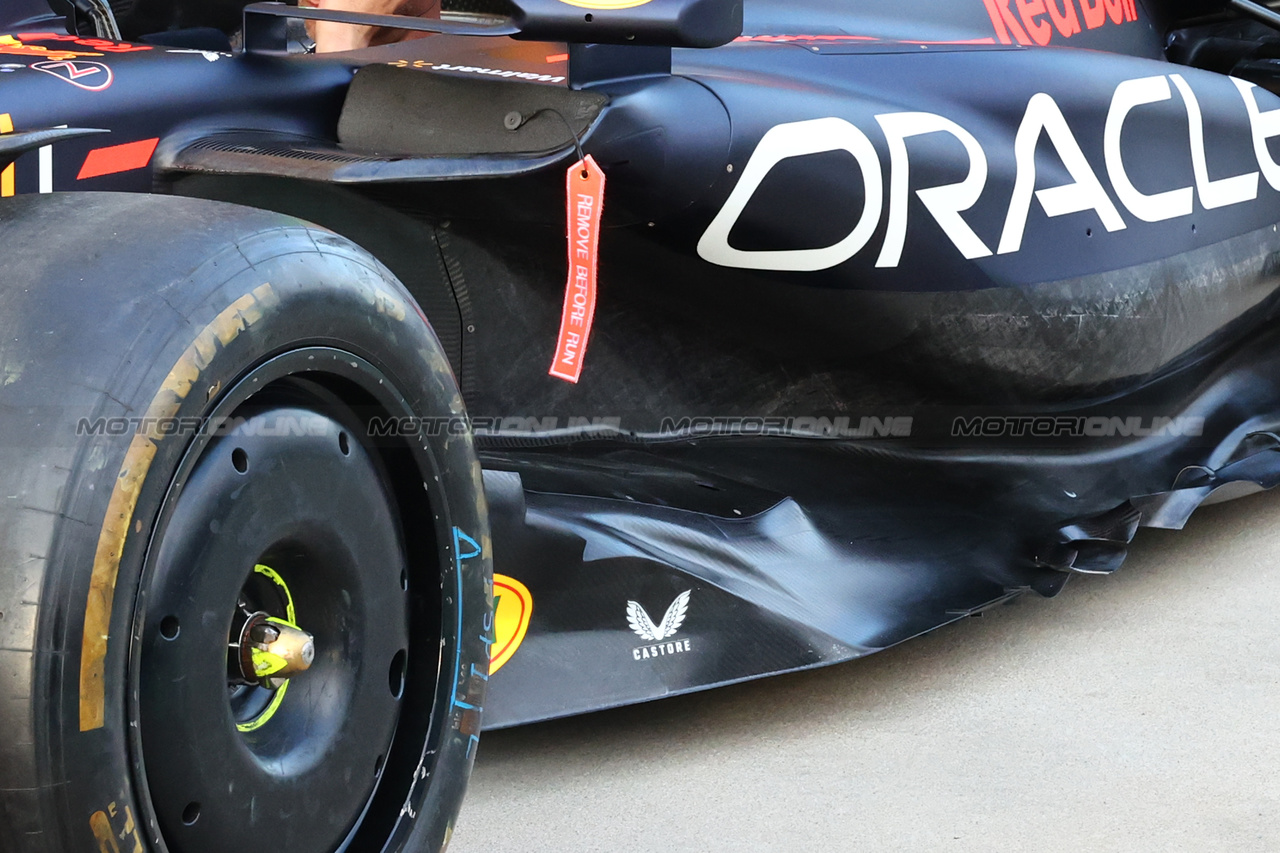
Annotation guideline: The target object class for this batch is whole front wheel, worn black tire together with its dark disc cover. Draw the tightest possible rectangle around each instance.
[0,195,492,853]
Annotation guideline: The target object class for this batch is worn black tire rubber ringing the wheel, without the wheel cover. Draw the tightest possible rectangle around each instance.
[0,193,492,853]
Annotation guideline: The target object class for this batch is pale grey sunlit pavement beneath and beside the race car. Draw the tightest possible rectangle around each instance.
[449,484,1280,853]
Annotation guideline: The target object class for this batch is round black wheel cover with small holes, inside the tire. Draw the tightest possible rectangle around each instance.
[131,351,442,853]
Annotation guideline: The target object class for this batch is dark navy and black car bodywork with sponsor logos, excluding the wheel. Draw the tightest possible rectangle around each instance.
[0,0,1280,726]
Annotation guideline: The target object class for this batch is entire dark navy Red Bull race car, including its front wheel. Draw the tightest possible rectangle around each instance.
[0,0,1280,853]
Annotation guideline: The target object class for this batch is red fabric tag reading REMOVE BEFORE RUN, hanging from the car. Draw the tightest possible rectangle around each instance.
[549,155,604,383]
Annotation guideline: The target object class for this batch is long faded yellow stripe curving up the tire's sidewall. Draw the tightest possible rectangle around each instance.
[79,284,279,731]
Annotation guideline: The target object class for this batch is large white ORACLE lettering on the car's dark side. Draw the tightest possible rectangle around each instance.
[698,74,1280,273]
